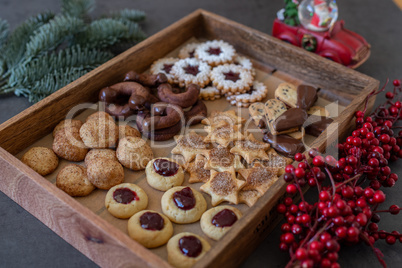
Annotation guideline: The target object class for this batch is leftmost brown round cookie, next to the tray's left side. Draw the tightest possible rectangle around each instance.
[21,147,59,176]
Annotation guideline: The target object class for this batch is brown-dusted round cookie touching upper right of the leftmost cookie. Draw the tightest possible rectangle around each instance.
[52,129,88,162]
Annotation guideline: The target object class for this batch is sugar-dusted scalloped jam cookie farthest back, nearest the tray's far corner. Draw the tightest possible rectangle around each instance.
[194,40,236,66]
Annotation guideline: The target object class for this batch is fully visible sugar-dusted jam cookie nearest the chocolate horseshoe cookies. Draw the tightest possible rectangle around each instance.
[171,58,211,88]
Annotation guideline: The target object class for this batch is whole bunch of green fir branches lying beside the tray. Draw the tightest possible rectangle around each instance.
[0,0,146,102]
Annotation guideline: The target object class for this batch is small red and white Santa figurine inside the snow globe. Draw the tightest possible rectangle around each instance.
[307,0,332,32]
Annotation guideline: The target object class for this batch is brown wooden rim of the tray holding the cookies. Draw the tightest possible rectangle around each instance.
[0,9,379,267]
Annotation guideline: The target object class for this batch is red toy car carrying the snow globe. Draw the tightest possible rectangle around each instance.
[272,19,370,69]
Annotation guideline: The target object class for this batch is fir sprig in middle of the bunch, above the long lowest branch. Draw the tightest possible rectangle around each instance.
[25,16,85,58]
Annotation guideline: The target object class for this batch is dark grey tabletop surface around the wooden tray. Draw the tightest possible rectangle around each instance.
[0,0,402,268]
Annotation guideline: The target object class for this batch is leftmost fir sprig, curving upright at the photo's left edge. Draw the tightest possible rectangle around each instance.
[3,12,54,69]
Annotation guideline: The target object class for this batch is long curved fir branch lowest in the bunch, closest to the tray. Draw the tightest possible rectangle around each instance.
[9,45,113,88]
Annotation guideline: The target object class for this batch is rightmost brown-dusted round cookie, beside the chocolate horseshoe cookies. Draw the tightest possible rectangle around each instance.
[116,137,154,170]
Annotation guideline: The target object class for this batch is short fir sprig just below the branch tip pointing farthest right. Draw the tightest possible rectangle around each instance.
[75,18,129,48]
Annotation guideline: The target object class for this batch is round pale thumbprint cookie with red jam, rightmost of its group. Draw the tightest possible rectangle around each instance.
[200,206,242,240]
